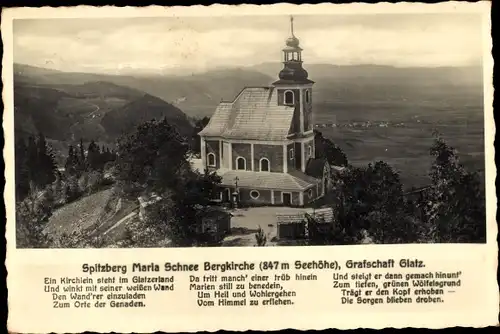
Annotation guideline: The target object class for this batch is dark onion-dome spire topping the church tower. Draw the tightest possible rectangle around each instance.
[274,16,312,84]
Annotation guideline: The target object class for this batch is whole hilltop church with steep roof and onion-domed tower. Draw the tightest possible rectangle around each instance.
[199,18,328,206]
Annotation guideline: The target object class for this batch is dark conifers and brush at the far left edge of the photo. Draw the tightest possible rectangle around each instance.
[15,133,116,247]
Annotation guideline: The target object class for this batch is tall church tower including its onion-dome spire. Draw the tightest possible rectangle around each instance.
[273,17,315,172]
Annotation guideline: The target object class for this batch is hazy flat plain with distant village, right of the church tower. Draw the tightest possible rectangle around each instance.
[315,104,484,187]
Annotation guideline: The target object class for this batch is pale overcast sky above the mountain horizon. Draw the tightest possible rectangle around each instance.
[14,14,482,73]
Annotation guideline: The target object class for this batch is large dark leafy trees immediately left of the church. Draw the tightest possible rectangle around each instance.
[116,120,220,247]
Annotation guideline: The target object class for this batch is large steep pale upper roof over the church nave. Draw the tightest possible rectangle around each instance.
[199,87,294,140]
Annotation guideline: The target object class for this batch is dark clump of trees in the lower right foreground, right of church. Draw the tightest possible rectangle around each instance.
[307,135,486,244]
